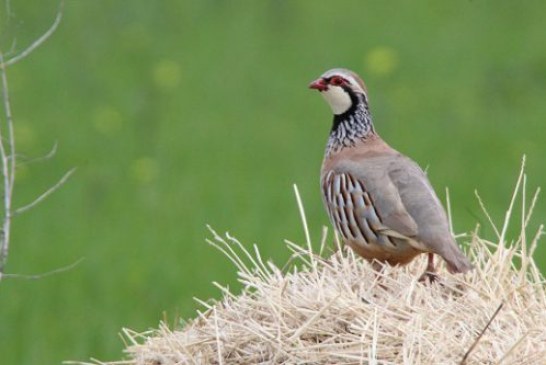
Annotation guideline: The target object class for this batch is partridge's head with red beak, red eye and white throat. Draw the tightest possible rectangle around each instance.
[309,68,367,115]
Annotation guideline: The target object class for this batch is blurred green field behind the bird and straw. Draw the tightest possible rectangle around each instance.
[0,0,546,364]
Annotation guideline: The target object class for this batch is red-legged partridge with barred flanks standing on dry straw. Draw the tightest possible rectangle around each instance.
[309,68,473,282]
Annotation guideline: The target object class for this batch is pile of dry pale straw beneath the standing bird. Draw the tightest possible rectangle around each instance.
[78,160,546,365]
